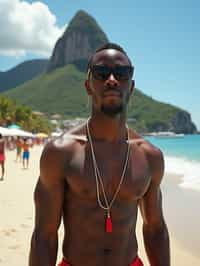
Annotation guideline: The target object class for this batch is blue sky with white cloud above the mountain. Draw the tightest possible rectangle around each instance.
[0,0,200,130]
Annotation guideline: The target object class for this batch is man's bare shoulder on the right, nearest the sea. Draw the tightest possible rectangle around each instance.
[130,131,164,183]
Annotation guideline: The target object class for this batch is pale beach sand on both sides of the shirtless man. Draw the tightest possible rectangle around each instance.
[0,147,200,266]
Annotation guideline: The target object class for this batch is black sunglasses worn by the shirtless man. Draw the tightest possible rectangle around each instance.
[88,65,134,81]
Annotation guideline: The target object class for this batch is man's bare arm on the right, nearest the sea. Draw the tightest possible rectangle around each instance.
[140,144,170,266]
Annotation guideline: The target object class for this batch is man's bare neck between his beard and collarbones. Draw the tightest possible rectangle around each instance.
[89,115,127,142]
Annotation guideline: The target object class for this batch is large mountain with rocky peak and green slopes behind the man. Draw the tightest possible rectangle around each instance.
[2,11,196,133]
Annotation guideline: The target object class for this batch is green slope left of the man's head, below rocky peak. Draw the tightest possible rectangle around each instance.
[5,65,87,117]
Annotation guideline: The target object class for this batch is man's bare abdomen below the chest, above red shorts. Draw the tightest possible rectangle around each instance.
[63,204,137,266]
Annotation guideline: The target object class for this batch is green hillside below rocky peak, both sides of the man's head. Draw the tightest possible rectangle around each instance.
[5,65,186,132]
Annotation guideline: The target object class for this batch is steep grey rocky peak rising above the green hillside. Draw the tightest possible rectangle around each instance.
[47,10,108,71]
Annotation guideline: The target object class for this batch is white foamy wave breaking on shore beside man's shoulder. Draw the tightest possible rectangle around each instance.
[165,155,200,191]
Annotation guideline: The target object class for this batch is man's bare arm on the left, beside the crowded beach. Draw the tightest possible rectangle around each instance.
[29,143,65,266]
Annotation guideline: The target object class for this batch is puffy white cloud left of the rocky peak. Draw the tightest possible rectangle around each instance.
[0,0,65,56]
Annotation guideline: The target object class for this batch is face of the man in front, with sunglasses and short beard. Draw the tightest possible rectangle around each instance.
[86,49,134,116]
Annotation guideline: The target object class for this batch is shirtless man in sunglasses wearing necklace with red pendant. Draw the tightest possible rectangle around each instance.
[29,43,170,266]
